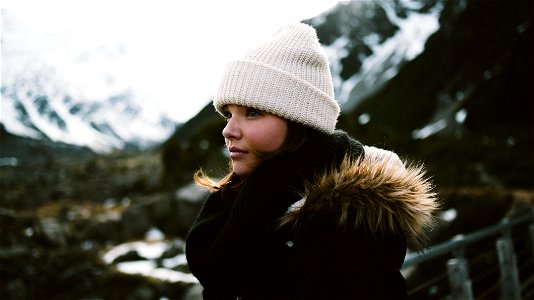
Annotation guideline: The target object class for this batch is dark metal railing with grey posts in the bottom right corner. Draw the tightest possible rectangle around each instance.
[402,210,534,300]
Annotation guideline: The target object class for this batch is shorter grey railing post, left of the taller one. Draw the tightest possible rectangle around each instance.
[447,258,473,300]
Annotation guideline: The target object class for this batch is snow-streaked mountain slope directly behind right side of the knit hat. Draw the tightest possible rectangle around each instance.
[308,1,443,111]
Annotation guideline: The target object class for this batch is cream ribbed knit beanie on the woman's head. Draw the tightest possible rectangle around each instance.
[213,23,339,133]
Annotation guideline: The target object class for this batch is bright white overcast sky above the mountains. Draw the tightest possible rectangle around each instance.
[1,0,338,122]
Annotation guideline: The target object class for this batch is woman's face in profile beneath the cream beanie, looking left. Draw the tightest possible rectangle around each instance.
[222,104,287,176]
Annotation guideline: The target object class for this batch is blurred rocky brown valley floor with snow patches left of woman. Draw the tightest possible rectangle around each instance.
[0,148,204,299]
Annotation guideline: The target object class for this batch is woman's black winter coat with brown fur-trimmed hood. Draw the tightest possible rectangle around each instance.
[186,132,436,299]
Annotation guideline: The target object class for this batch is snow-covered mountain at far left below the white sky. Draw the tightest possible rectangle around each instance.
[0,10,175,152]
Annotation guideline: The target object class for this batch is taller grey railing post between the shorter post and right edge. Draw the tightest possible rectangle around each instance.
[497,238,521,300]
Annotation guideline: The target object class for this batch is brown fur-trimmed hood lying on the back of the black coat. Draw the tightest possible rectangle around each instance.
[282,146,439,249]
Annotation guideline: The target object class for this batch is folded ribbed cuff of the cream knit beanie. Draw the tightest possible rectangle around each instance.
[213,60,339,133]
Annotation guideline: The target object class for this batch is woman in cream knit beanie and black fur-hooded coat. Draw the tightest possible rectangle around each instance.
[186,23,437,299]
